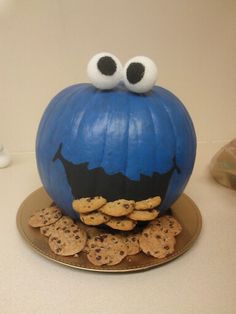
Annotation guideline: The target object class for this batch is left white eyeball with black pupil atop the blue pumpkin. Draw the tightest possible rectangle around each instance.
[87,52,122,89]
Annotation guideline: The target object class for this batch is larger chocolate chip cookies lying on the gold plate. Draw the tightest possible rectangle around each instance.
[29,205,182,266]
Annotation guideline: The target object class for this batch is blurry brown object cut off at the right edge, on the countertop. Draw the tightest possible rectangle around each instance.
[210,138,236,190]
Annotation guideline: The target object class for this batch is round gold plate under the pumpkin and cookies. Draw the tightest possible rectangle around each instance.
[16,187,202,272]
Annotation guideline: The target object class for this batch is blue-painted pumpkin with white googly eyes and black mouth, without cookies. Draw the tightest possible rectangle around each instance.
[36,54,196,218]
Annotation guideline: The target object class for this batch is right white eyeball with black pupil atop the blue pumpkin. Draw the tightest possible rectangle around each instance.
[123,56,157,93]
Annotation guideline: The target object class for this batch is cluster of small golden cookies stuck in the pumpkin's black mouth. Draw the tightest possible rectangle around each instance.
[72,196,161,231]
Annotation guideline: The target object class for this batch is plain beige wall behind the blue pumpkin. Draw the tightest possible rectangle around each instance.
[0,0,236,152]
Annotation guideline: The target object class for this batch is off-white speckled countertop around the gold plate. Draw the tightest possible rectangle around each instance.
[0,143,236,314]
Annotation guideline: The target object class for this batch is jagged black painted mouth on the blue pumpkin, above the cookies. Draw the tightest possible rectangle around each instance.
[53,144,180,201]
